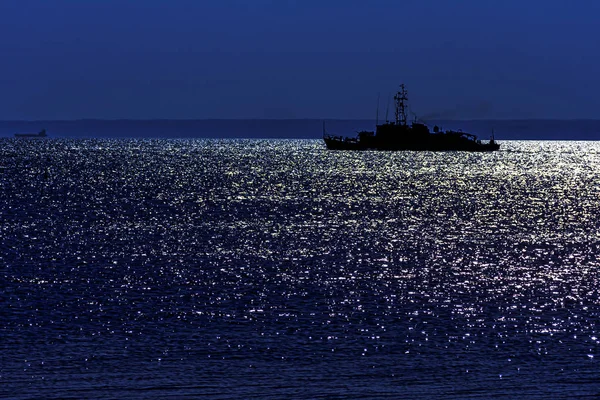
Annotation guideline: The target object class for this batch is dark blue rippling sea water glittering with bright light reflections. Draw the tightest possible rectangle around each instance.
[0,139,600,399]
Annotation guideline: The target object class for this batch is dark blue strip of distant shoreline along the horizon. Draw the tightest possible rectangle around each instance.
[0,118,600,141]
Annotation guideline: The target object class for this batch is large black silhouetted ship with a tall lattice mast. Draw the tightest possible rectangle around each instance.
[323,84,500,152]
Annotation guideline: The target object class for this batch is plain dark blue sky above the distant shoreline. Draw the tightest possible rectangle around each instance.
[0,0,600,119]
